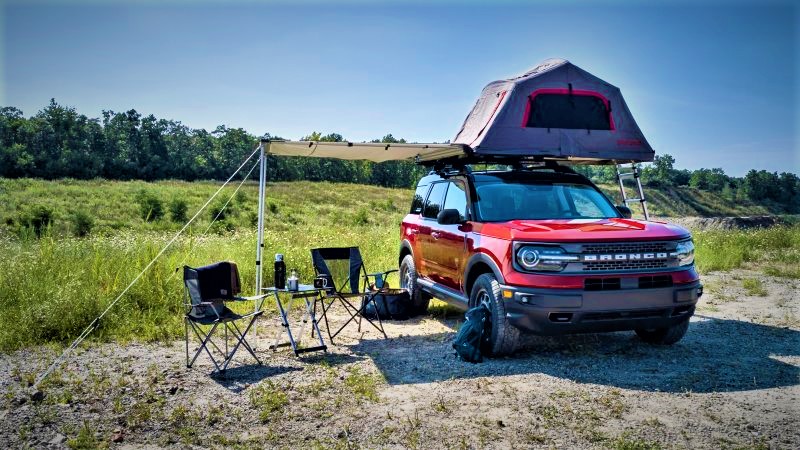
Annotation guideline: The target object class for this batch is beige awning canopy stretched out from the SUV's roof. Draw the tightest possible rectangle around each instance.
[262,140,470,163]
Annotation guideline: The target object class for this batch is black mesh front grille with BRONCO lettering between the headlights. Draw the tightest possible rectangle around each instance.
[581,242,674,272]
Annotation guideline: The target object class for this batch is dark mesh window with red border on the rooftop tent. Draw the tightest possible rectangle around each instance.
[525,94,611,130]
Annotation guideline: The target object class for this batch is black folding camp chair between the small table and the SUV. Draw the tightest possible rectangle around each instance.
[311,247,397,342]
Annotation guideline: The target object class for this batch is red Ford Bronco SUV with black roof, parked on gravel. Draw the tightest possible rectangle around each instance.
[399,164,703,355]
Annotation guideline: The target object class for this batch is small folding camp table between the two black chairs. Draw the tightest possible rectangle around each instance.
[263,284,328,356]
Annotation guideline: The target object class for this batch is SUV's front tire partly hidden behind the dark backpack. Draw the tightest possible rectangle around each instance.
[469,273,519,356]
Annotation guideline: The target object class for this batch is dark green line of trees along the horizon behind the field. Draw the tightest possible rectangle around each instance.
[0,100,800,212]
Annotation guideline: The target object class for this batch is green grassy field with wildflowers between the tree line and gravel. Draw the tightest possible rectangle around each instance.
[0,180,800,351]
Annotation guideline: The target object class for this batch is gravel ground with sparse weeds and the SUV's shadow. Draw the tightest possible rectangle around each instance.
[0,271,800,448]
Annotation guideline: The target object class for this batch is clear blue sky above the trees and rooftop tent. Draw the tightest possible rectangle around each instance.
[0,0,800,175]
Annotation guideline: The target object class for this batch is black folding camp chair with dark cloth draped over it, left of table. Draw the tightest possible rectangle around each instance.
[183,262,265,373]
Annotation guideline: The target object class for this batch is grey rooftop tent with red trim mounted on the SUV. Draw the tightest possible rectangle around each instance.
[453,59,654,162]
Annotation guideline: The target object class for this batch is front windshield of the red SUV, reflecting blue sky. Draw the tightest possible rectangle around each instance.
[475,178,620,222]
